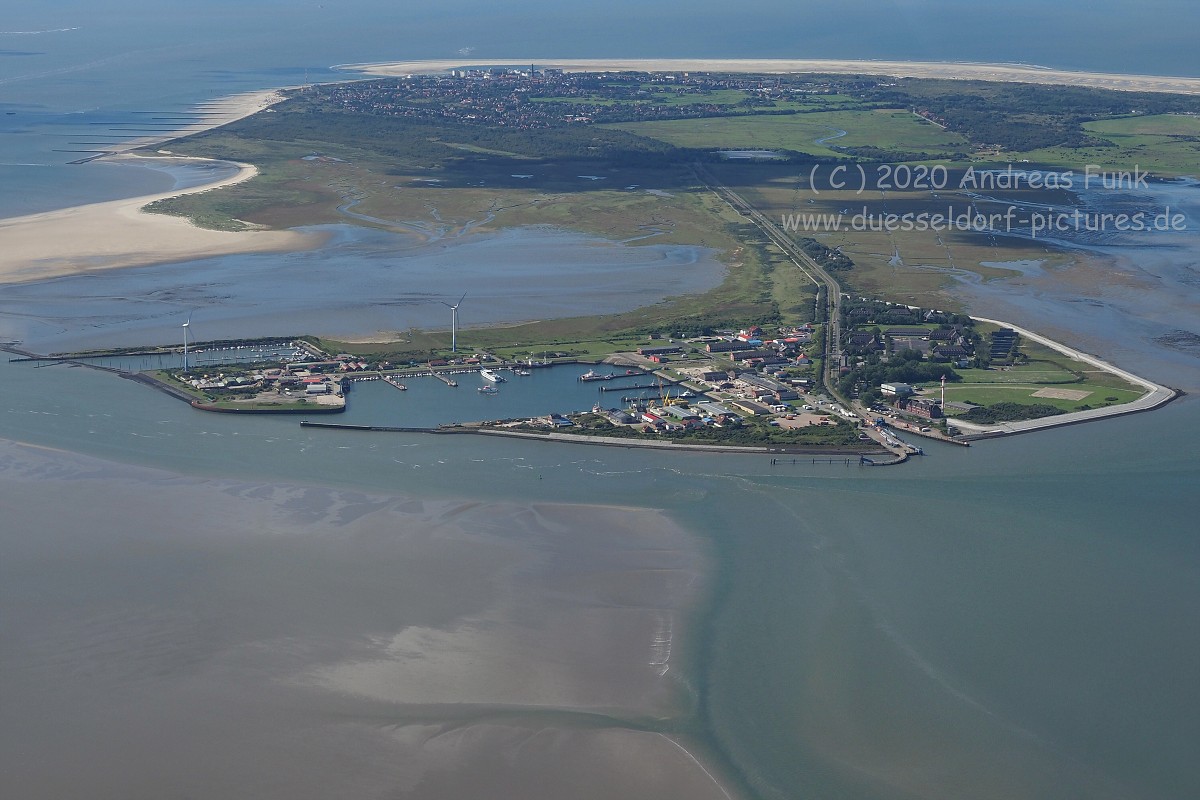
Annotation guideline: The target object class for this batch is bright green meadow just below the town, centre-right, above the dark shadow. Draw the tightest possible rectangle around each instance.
[606,109,966,156]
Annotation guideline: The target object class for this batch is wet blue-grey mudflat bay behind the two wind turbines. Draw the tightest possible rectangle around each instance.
[0,224,725,350]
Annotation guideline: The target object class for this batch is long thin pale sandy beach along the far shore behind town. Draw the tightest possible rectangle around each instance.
[338,59,1200,95]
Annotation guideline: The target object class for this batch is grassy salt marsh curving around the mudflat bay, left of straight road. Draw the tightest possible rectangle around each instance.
[142,105,804,357]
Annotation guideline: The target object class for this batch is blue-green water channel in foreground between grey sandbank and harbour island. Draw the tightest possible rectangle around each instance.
[0,352,1200,799]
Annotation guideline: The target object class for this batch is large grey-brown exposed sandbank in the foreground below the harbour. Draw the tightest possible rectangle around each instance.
[0,440,730,800]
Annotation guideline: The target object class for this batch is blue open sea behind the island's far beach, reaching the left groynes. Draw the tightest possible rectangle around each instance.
[0,0,1200,216]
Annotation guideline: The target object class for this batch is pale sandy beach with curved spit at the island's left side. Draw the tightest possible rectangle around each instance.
[0,91,317,283]
